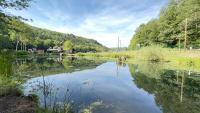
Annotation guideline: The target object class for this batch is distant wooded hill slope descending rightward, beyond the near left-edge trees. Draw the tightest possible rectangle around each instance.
[25,26,107,52]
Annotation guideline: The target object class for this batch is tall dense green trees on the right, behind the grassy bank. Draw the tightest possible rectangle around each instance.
[129,0,200,49]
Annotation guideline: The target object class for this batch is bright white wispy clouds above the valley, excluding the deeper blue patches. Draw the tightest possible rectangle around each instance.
[10,0,167,47]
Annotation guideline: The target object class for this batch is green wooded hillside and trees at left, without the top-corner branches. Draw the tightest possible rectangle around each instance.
[0,18,107,52]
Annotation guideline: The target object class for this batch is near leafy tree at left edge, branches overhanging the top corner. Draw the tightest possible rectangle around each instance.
[0,0,32,50]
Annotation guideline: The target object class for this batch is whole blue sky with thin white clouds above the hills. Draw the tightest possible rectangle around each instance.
[9,0,167,47]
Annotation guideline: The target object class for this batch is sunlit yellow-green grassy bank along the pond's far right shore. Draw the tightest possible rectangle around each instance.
[76,46,200,70]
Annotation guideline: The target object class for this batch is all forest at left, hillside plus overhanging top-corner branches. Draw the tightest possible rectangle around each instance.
[0,0,107,52]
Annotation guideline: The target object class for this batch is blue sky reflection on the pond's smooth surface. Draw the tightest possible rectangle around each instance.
[24,62,161,113]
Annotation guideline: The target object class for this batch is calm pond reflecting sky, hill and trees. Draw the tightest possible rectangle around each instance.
[0,57,200,113]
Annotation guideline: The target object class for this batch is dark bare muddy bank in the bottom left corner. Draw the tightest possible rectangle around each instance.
[0,94,37,113]
